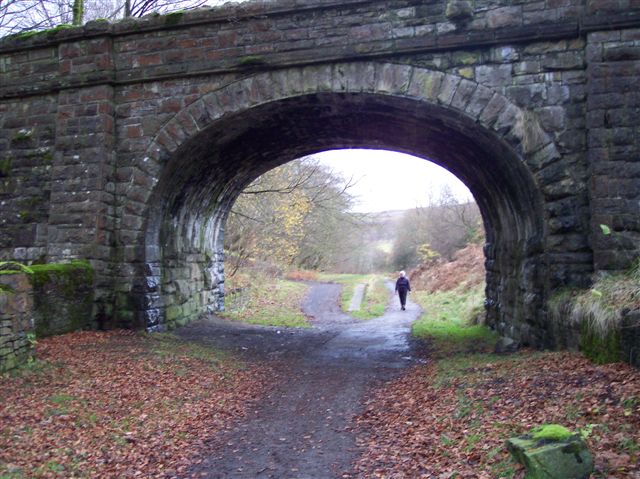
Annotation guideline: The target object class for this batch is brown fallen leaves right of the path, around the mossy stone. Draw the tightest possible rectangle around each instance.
[354,351,640,479]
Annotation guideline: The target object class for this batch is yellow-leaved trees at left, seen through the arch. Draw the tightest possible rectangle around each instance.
[225,158,363,275]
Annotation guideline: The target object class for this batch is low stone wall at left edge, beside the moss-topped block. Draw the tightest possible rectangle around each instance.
[0,273,35,373]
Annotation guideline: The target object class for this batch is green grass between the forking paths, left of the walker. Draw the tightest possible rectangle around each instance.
[318,273,390,319]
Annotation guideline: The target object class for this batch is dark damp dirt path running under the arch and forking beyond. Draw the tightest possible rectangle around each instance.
[179,283,420,479]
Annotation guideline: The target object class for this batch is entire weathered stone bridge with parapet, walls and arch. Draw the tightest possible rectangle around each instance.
[0,0,640,346]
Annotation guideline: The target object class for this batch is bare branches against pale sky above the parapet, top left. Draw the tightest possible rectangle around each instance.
[0,0,219,36]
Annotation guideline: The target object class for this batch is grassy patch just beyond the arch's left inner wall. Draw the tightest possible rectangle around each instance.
[222,278,311,328]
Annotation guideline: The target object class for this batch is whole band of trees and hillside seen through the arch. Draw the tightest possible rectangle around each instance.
[225,163,484,276]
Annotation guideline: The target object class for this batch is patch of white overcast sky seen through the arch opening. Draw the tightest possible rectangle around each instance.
[313,149,473,213]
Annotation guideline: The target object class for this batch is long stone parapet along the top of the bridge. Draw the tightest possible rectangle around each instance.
[0,0,639,97]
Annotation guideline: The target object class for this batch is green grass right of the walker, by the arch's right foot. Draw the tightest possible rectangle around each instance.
[413,285,497,355]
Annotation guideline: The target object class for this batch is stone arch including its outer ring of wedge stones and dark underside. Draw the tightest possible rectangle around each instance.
[122,62,559,345]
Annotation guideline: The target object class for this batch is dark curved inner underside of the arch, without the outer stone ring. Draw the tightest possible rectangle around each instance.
[134,92,544,344]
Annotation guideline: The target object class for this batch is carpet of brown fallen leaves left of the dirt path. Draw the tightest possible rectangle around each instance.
[0,331,271,479]
